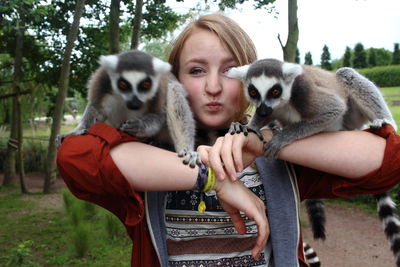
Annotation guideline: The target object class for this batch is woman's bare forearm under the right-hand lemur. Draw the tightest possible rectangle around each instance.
[278,131,386,178]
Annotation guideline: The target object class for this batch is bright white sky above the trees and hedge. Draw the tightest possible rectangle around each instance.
[167,0,400,64]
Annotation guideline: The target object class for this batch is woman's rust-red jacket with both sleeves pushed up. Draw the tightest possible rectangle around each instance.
[57,123,400,267]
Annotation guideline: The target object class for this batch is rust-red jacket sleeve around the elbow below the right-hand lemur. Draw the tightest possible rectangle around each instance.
[297,125,400,200]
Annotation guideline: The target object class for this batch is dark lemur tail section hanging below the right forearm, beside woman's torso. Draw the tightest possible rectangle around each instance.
[306,199,326,240]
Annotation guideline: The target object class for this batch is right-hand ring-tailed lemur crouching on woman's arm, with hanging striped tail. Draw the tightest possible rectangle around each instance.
[227,59,400,266]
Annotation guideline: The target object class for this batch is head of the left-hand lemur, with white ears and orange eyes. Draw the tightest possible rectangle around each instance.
[100,51,171,110]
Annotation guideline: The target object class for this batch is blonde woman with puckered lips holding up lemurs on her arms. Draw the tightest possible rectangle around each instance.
[57,14,399,266]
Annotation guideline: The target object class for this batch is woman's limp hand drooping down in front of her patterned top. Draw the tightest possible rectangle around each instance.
[215,179,269,259]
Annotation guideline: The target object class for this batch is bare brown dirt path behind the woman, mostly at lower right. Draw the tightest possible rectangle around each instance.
[0,174,395,267]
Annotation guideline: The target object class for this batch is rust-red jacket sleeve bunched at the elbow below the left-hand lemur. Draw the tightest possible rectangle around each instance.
[57,123,144,226]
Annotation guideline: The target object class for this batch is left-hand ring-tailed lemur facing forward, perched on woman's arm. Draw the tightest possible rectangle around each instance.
[57,50,200,168]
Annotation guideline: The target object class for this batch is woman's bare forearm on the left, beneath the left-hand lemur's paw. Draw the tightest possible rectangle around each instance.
[110,142,198,191]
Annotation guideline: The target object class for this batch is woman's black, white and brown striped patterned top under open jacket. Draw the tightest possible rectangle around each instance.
[165,166,271,267]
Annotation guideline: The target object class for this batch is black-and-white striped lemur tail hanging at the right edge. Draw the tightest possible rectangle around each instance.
[375,193,400,267]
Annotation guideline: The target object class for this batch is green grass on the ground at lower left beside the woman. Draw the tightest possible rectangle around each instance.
[0,186,131,266]
